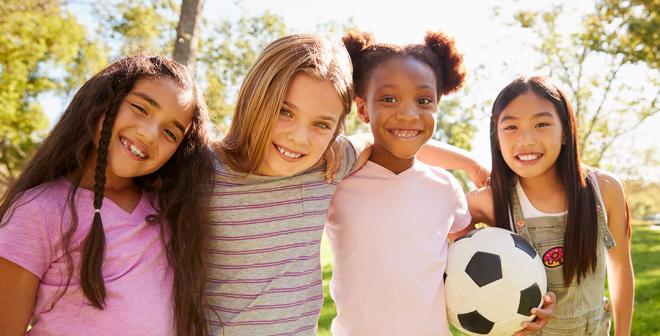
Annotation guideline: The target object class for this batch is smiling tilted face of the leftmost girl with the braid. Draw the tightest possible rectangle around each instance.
[96,78,193,184]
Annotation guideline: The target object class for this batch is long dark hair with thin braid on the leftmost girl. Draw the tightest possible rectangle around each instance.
[0,56,211,335]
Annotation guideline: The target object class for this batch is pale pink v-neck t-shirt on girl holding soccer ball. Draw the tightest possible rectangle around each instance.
[326,161,471,336]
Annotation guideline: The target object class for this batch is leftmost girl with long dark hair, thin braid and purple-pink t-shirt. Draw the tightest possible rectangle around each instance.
[0,56,211,335]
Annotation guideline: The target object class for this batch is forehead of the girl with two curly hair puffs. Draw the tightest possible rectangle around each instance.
[369,56,436,90]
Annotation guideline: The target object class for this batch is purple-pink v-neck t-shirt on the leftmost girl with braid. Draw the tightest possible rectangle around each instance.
[0,178,174,336]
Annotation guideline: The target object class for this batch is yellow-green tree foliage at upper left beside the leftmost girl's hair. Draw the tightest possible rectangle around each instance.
[0,0,105,185]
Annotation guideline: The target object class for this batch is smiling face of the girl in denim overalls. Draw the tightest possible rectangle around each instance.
[497,90,563,178]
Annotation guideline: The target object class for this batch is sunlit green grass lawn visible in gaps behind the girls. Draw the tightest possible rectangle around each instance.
[318,225,660,336]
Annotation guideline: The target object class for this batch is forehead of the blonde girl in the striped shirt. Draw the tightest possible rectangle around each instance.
[284,73,344,119]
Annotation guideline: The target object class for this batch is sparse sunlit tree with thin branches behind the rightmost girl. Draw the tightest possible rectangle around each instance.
[508,1,660,167]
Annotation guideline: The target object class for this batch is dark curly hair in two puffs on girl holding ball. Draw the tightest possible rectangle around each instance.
[342,31,466,99]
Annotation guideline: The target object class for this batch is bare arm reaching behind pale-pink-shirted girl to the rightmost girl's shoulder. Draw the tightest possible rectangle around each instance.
[417,139,490,187]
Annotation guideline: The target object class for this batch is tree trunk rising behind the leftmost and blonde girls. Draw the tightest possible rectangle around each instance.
[172,0,204,73]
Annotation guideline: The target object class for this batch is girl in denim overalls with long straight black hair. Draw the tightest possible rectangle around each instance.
[468,77,634,335]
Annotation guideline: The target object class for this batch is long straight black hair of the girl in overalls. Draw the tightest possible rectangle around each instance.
[490,77,605,283]
